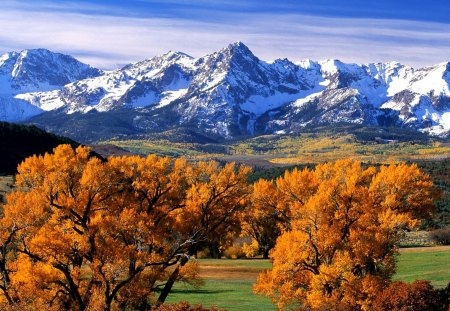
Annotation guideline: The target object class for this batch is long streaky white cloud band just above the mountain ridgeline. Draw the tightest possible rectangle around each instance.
[0,1,450,69]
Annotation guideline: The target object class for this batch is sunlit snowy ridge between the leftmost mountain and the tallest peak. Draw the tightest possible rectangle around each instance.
[16,52,192,114]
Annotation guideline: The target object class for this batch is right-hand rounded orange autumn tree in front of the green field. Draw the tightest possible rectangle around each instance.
[254,160,433,310]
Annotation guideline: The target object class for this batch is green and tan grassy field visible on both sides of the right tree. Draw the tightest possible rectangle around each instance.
[167,247,450,310]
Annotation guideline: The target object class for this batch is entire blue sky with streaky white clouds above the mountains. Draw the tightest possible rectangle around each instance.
[0,0,450,69]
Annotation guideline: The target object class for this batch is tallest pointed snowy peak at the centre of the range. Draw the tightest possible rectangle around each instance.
[171,42,323,137]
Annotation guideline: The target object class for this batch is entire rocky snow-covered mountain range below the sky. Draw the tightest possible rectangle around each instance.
[0,42,450,140]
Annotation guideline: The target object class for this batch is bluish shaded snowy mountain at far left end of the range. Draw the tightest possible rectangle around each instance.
[0,49,103,121]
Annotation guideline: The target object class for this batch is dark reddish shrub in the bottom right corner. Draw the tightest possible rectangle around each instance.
[373,280,450,311]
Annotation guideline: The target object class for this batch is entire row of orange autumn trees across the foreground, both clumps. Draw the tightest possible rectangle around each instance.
[0,145,442,310]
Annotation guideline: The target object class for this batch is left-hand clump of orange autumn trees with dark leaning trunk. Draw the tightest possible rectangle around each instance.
[0,145,249,310]
